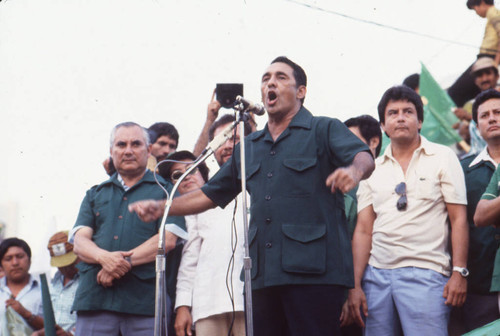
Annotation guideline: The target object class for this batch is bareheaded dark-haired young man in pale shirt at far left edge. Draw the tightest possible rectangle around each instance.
[0,238,43,330]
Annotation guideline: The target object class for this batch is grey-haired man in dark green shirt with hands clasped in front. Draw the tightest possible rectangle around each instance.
[73,122,187,336]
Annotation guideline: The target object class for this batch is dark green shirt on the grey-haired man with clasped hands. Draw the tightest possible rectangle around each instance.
[73,170,185,316]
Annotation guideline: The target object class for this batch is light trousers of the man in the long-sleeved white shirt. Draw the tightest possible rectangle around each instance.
[195,312,245,336]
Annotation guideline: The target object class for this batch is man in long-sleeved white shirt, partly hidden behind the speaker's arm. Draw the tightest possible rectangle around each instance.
[171,114,251,336]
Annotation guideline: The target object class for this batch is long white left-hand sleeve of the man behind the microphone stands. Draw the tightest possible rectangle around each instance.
[175,216,202,309]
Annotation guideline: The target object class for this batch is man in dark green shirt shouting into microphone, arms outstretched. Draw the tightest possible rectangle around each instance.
[129,57,374,336]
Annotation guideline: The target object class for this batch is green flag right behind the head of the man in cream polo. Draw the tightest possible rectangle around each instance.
[419,63,462,146]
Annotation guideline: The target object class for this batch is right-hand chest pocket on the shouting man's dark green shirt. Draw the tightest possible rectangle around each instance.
[280,157,319,197]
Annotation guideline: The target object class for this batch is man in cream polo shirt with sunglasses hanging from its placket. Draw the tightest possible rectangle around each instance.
[349,86,468,336]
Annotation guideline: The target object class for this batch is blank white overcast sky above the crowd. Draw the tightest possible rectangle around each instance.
[0,0,485,271]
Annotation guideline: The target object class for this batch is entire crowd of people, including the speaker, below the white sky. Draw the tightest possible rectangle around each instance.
[0,0,500,336]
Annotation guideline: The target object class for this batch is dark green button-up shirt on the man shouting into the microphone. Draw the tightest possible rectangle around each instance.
[202,107,369,289]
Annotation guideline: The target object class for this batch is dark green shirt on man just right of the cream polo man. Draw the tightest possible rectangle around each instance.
[460,156,500,295]
